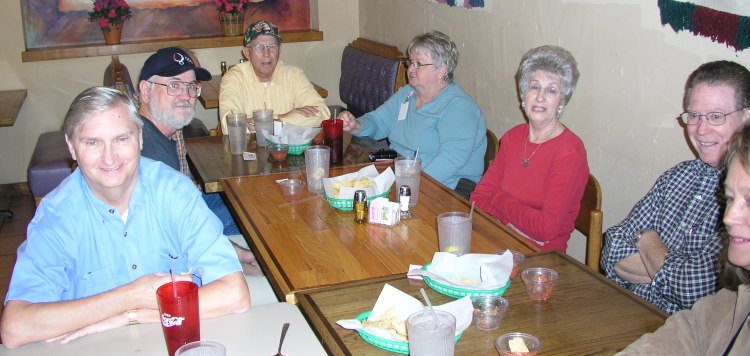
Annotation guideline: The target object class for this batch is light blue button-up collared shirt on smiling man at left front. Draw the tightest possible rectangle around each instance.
[6,158,241,303]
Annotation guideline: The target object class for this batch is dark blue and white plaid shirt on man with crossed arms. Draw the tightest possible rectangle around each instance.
[601,160,725,314]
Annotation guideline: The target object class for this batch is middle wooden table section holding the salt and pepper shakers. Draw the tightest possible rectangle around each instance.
[220,164,536,303]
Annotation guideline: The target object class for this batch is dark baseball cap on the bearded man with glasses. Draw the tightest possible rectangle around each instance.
[139,47,211,81]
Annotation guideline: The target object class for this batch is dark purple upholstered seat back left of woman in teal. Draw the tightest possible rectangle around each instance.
[339,38,406,117]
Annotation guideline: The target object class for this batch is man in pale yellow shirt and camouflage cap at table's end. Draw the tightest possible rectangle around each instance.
[219,20,330,134]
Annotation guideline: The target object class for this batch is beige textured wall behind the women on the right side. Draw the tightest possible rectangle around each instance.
[359,0,750,262]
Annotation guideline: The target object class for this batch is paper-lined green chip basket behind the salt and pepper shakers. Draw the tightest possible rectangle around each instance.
[323,165,396,211]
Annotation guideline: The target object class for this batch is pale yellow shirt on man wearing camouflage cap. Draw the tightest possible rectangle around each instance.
[219,61,331,135]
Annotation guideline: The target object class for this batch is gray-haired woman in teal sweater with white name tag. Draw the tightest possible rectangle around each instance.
[338,31,487,189]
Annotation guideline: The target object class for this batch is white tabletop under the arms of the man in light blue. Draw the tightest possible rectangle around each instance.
[0,303,326,356]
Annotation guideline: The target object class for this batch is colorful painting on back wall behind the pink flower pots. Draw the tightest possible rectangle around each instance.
[21,0,310,50]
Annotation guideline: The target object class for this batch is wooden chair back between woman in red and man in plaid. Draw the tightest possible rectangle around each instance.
[576,174,603,273]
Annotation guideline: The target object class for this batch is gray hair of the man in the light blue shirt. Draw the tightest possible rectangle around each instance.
[63,87,143,137]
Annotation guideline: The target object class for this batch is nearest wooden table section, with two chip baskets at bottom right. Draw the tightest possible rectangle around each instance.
[297,252,667,355]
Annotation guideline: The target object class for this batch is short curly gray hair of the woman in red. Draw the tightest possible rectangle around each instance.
[516,46,580,105]
